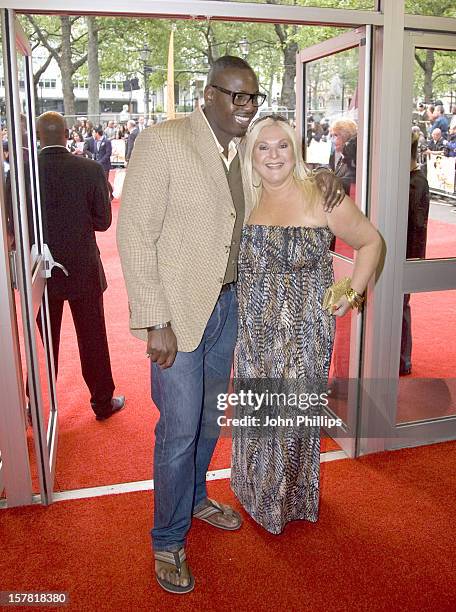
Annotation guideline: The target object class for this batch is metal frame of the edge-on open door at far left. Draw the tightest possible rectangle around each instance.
[1,9,58,505]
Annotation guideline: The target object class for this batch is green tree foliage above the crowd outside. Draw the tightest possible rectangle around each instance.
[19,0,456,111]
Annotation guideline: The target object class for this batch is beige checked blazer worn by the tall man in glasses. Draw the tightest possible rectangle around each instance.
[117,110,251,351]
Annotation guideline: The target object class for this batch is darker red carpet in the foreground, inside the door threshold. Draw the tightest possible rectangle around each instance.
[0,442,456,612]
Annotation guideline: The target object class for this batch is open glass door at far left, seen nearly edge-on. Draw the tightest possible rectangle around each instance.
[1,9,58,504]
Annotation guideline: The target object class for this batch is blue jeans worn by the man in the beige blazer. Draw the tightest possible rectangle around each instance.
[151,285,237,550]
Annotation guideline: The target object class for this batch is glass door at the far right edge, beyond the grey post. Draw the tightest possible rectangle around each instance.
[387,32,456,448]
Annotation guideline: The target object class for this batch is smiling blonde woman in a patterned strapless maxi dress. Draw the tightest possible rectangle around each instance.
[232,116,381,533]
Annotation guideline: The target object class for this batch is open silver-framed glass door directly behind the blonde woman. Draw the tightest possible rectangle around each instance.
[296,26,371,457]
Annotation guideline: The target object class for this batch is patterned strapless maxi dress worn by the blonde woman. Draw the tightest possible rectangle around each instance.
[231,224,335,533]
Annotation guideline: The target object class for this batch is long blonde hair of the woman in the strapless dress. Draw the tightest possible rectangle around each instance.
[243,115,316,207]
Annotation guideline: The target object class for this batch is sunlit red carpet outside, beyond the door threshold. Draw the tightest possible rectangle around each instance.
[22,184,456,490]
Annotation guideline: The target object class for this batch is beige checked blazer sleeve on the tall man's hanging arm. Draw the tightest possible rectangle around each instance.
[117,130,171,335]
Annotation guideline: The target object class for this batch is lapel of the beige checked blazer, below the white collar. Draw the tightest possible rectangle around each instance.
[190,109,233,209]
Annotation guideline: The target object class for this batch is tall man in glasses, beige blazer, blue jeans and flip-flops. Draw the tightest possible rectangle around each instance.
[117,56,343,593]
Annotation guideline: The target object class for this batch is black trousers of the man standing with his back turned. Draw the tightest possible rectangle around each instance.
[37,293,114,414]
